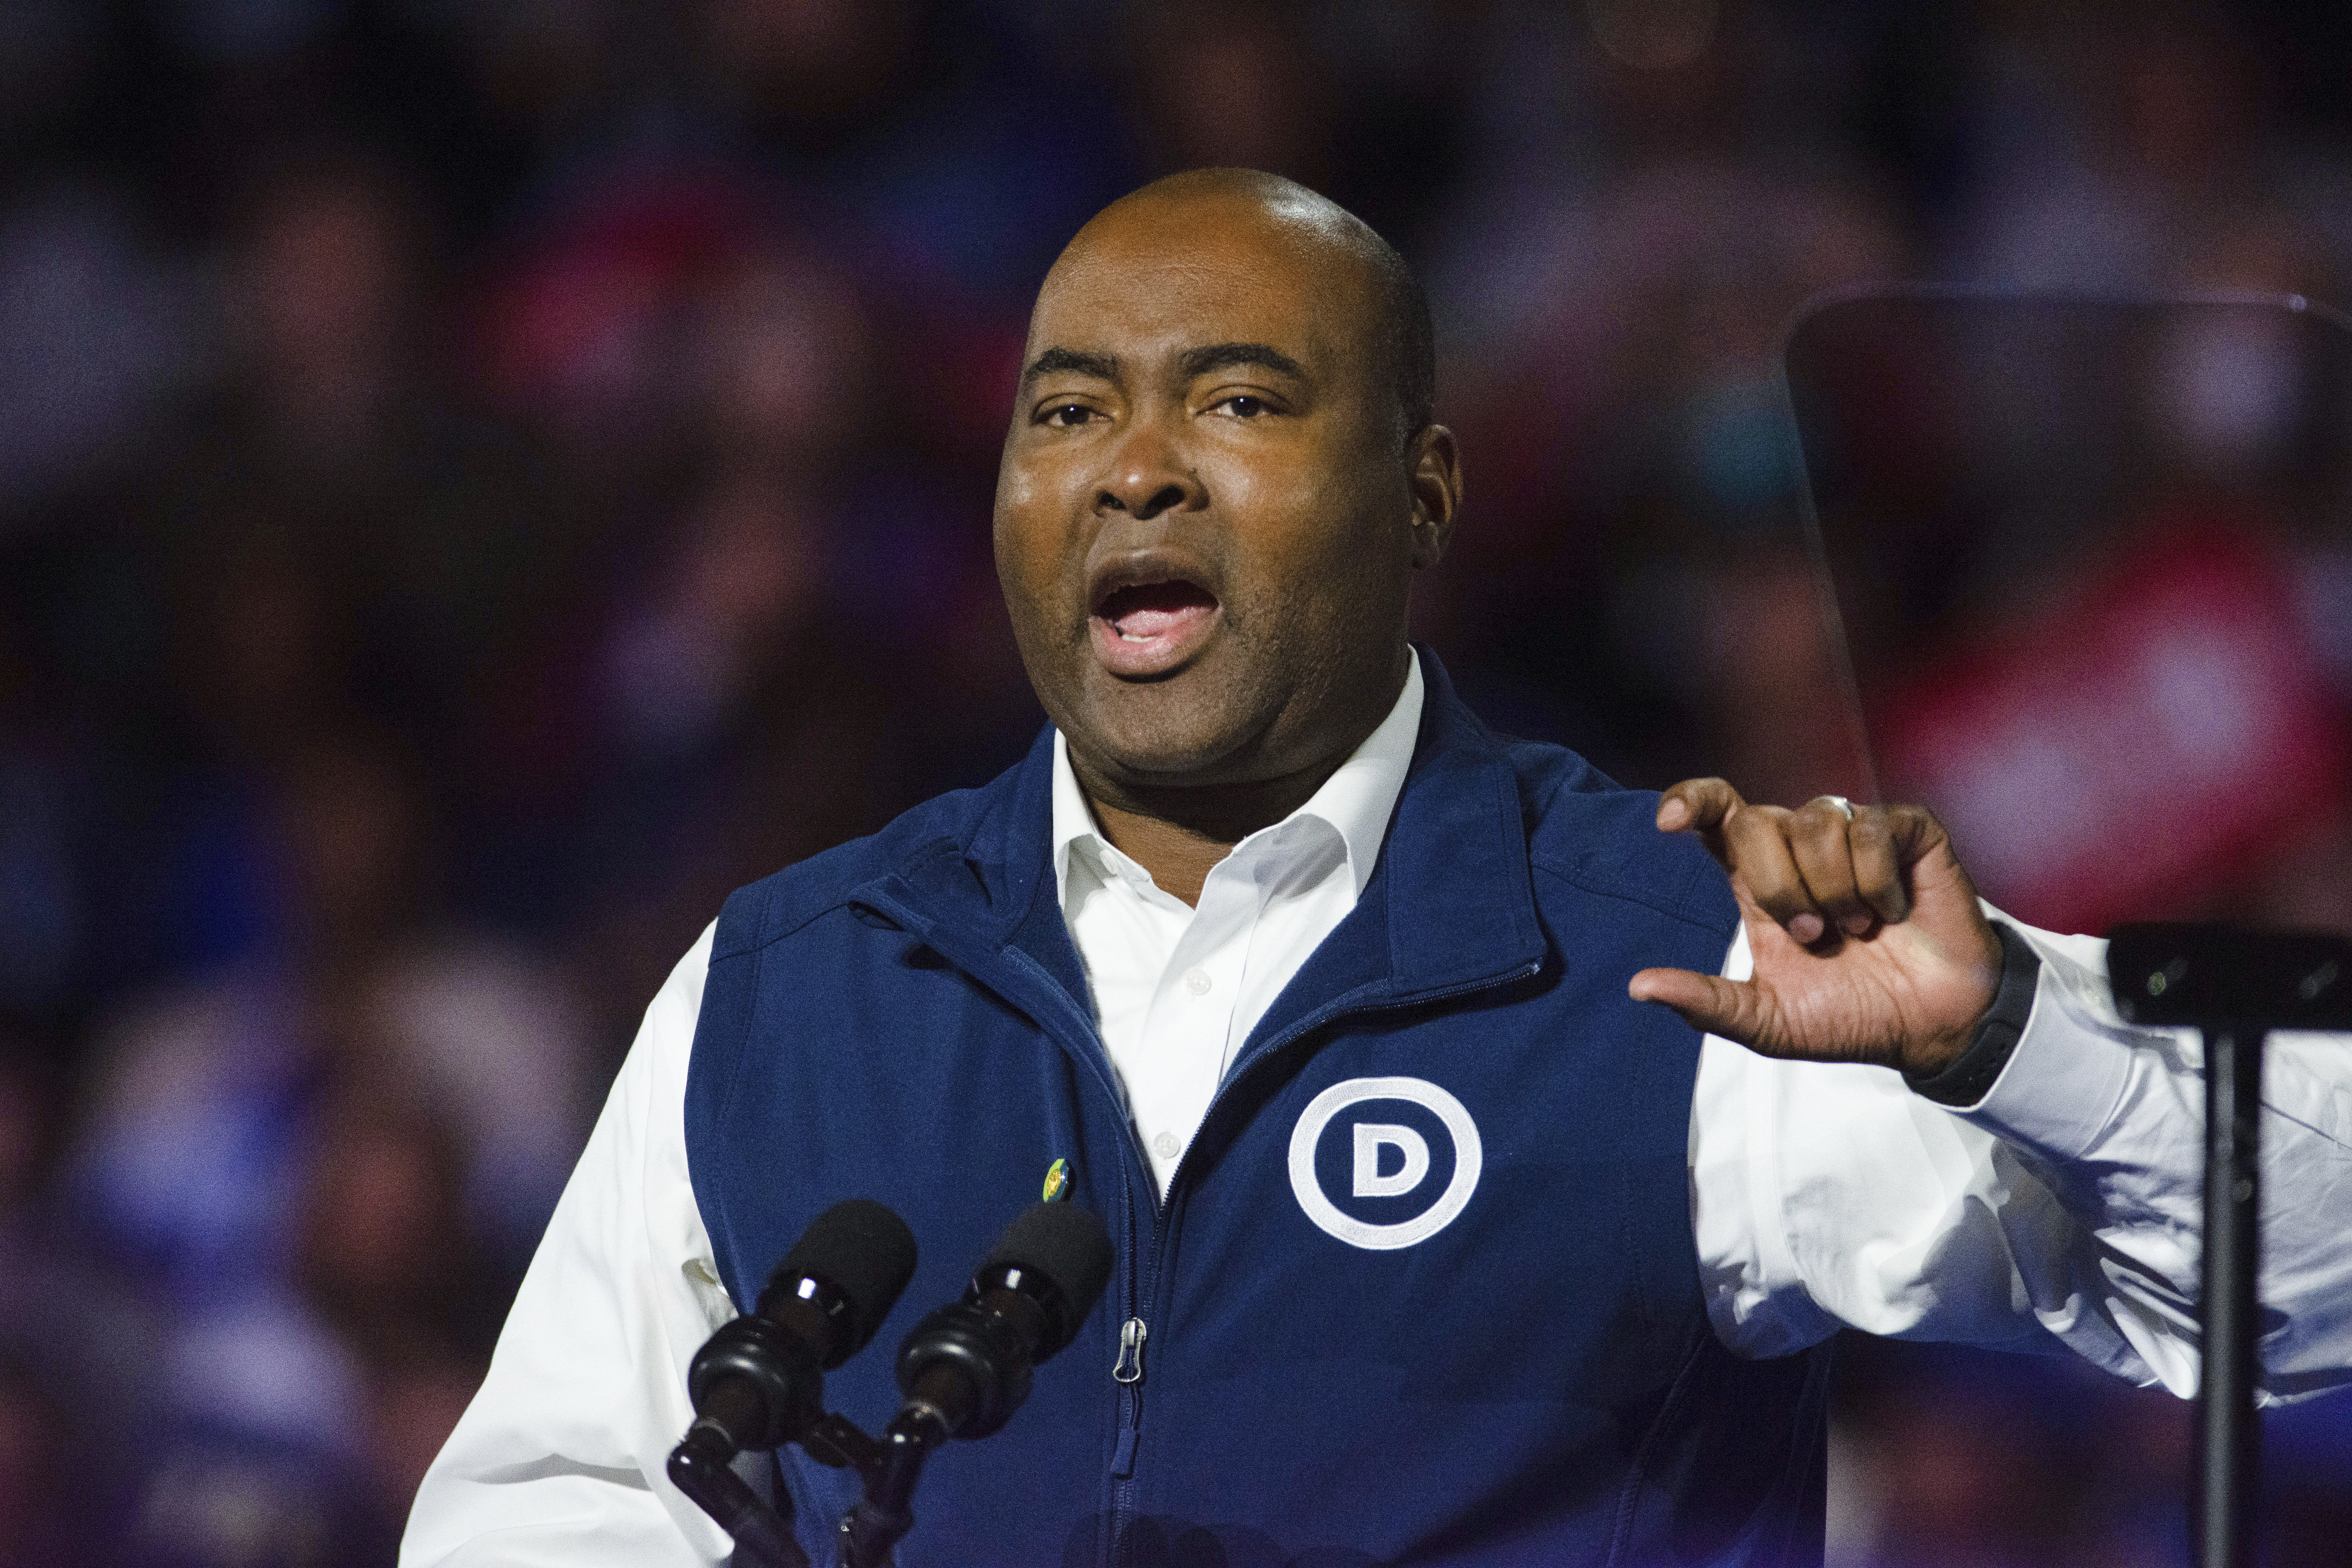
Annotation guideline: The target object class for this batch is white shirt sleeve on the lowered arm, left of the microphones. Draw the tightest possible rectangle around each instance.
[400,931,734,1568]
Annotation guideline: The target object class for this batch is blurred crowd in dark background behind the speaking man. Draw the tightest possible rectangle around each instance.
[0,0,2352,1568]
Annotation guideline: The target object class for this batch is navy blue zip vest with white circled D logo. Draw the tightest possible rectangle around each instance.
[687,651,1828,1568]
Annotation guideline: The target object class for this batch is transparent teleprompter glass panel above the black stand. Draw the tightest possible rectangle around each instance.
[1785,289,2352,931]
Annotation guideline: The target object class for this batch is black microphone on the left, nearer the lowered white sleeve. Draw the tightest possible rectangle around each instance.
[687,1199,915,1450]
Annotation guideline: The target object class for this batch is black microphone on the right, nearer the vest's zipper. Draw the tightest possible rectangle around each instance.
[894,1203,1112,1439]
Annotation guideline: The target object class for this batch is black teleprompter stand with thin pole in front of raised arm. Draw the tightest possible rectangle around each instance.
[2107,924,2352,1568]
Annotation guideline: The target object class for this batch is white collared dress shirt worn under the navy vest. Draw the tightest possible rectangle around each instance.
[400,668,2352,1568]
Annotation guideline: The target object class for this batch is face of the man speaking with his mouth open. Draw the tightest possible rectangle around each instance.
[995,195,1439,785]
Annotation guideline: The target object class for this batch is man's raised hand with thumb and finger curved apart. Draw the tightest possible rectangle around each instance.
[1628,778,2002,1077]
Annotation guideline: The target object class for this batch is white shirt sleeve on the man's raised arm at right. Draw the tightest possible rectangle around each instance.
[1691,922,2352,1399]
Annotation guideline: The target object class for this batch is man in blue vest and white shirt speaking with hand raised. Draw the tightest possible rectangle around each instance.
[402,172,2352,1568]
